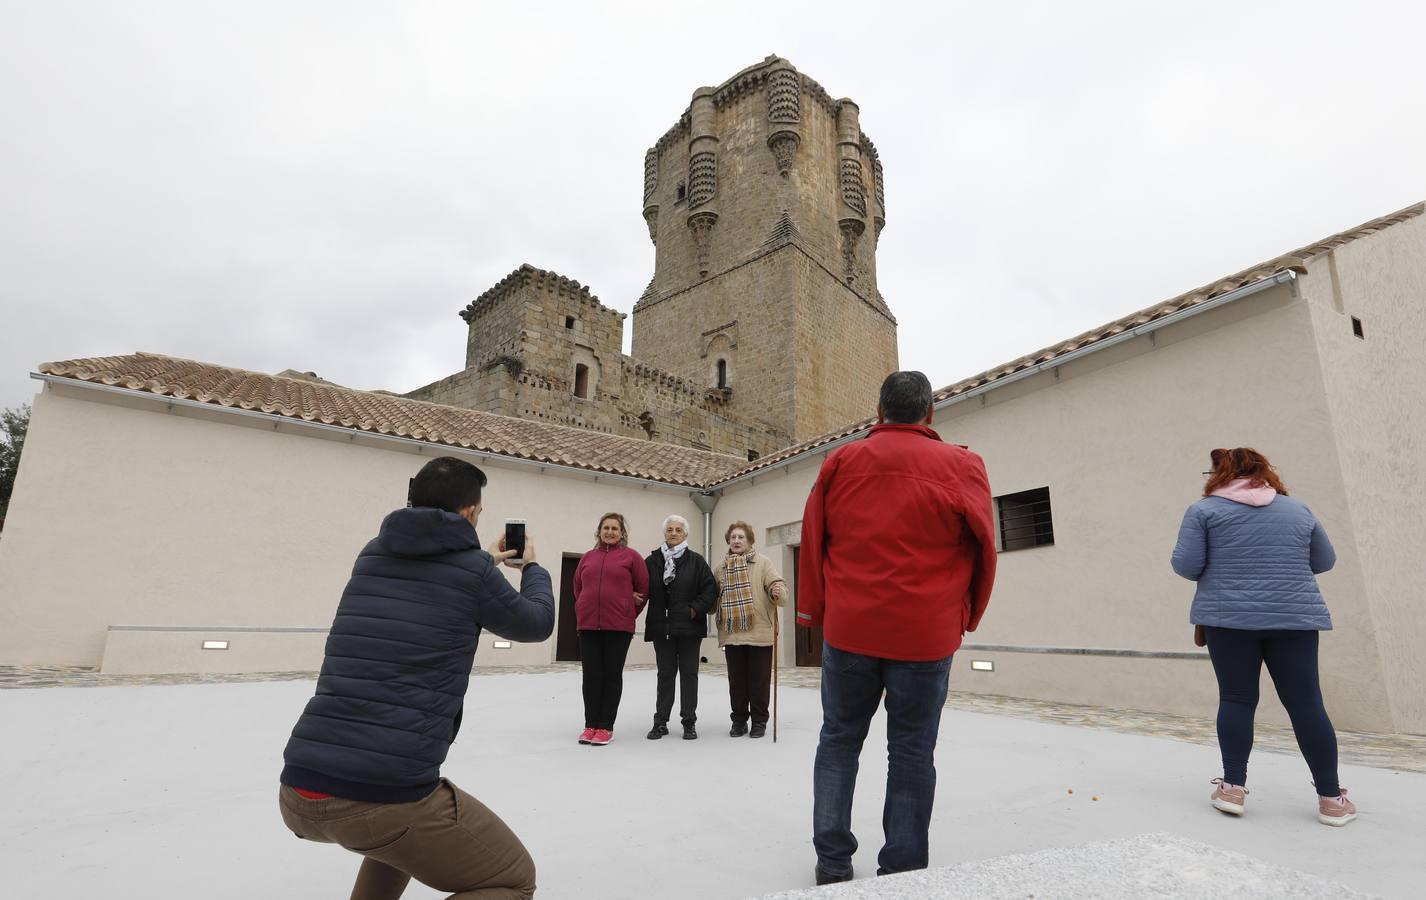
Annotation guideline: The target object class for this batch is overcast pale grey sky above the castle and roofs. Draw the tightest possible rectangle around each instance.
[0,0,1426,406]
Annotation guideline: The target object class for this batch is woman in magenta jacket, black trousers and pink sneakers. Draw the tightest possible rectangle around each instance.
[575,512,649,747]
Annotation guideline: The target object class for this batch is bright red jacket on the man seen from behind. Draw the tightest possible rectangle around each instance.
[797,425,995,660]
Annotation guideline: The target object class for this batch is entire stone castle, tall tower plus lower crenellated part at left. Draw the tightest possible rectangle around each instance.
[408,57,897,459]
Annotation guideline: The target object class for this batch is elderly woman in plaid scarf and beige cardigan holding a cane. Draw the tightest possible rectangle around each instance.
[714,522,787,737]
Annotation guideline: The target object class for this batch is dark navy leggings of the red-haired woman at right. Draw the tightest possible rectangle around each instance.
[1204,628,1340,797]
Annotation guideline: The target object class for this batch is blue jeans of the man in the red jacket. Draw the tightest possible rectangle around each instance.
[811,643,951,874]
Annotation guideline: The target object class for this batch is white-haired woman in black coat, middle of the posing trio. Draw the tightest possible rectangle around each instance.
[643,515,719,740]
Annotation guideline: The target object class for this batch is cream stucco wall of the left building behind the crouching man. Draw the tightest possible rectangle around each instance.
[0,385,716,670]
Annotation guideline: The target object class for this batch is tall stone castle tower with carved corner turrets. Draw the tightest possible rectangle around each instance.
[633,57,897,441]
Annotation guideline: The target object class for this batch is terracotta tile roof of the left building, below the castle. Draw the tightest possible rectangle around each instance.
[40,354,747,486]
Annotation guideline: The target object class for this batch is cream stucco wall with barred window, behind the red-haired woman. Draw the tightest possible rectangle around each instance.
[714,285,1419,730]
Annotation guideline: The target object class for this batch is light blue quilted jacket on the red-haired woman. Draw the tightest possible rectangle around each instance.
[1172,495,1336,630]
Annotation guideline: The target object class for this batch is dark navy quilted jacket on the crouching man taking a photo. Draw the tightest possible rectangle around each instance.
[281,508,555,803]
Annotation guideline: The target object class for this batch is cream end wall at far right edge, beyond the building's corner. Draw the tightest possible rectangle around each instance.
[1302,218,1426,733]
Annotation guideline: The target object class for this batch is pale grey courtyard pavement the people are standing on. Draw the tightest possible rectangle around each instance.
[0,670,1426,900]
